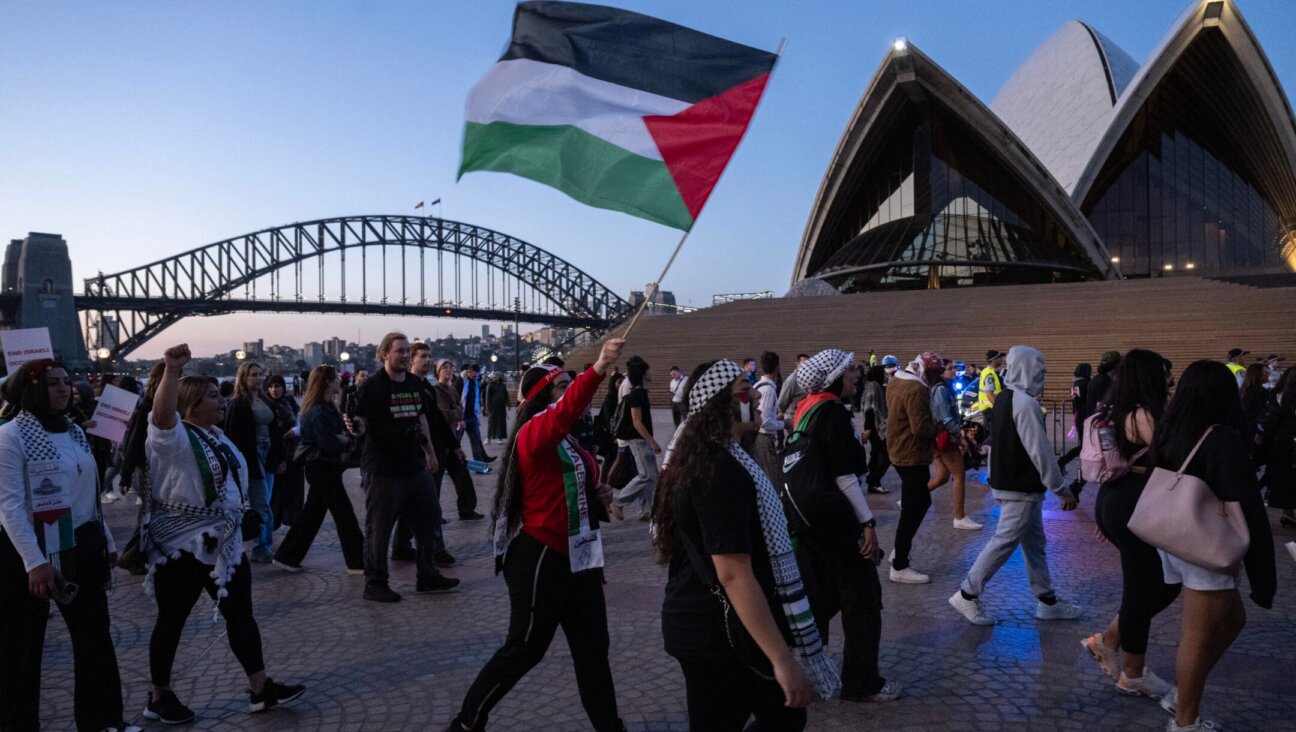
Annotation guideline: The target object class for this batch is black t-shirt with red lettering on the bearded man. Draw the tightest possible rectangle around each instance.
[355,369,437,478]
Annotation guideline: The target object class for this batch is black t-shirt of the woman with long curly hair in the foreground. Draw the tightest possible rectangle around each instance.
[661,446,787,658]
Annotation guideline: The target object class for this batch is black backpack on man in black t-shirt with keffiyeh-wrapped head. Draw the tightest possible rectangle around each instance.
[779,404,834,536]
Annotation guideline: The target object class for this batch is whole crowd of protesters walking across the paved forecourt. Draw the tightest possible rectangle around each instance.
[0,333,1296,732]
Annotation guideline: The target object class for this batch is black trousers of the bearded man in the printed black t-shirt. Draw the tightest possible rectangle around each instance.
[364,473,441,587]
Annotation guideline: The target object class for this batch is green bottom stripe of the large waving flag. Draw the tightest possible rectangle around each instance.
[459,122,693,231]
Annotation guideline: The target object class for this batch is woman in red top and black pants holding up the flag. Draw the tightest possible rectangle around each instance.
[447,338,625,732]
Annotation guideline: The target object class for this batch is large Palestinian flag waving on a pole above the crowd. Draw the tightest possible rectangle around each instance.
[459,1,776,231]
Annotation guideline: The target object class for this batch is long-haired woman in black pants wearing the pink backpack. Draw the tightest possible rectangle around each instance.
[1082,349,1179,700]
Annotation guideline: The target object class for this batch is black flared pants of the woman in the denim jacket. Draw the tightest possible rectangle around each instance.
[275,460,364,569]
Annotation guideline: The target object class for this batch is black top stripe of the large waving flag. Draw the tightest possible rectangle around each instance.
[500,0,775,104]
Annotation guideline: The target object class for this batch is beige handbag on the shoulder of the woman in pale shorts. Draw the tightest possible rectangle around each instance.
[1128,425,1251,574]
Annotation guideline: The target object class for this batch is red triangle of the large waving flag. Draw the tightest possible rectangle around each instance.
[644,74,770,219]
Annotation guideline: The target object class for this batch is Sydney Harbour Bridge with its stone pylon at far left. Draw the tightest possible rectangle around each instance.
[0,215,631,360]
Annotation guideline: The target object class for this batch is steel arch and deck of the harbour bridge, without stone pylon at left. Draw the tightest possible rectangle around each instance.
[76,215,631,358]
